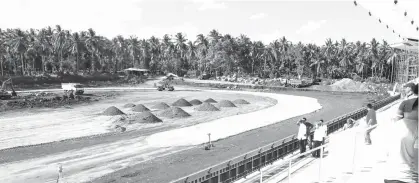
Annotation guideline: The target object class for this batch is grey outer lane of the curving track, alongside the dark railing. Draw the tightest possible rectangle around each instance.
[89,91,366,183]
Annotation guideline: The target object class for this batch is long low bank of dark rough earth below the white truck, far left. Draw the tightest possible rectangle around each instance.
[0,95,92,112]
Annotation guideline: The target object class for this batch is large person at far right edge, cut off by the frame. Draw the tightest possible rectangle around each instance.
[384,83,419,183]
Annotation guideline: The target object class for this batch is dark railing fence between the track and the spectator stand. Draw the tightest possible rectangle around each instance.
[172,95,400,183]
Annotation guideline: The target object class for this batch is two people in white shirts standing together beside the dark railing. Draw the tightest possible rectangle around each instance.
[297,118,327,158]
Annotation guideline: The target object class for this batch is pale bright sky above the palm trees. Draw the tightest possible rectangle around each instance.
[0,0,419,45]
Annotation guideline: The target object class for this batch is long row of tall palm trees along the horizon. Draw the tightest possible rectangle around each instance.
[0,25,395,78]
